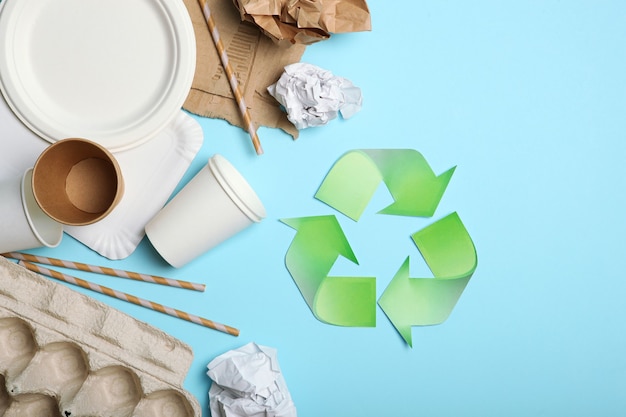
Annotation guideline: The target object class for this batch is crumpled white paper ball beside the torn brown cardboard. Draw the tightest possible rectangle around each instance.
[267,63,362,129]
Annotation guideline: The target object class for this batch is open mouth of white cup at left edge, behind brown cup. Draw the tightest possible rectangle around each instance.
[20,168,63,248]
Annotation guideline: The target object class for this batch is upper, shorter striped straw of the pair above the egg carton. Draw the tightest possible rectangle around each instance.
[2,252,206,292]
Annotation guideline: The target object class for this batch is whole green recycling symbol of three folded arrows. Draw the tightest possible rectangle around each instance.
[281,149,478,346]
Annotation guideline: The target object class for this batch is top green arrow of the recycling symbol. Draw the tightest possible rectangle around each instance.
[315,149,455,220]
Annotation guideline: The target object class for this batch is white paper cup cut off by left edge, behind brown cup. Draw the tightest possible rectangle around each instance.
[0,169,63,253]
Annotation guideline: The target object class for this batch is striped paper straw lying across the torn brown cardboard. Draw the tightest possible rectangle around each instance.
[198,0,263,155]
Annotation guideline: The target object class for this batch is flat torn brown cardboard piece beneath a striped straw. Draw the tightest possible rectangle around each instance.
[183,0,305,141]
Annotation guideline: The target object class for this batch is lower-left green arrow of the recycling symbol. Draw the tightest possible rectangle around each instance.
[281,215,376,327]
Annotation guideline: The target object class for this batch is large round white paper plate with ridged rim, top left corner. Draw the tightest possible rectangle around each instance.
[0,0,196,151]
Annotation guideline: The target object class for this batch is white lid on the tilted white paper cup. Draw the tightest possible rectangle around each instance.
[207,154,267,223]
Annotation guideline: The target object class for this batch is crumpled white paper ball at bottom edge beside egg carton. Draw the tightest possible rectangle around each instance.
[207,343,297,417]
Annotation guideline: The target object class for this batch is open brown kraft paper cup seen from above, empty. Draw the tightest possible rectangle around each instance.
[33,138,124,226]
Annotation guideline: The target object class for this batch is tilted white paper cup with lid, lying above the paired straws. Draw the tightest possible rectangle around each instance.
[146,154,266,268]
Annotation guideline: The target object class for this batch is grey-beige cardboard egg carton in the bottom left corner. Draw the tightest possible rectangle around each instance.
[0,256,202,417]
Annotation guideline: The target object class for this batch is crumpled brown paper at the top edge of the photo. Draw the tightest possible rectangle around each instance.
[233,0,372,45]
